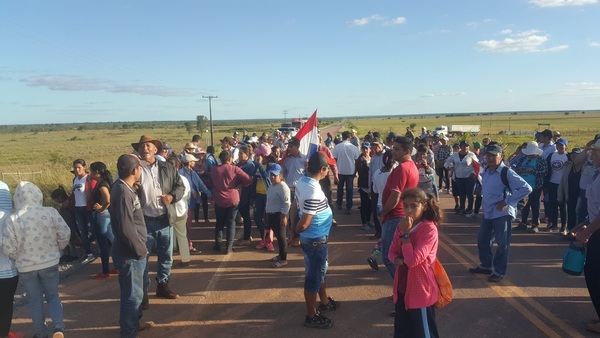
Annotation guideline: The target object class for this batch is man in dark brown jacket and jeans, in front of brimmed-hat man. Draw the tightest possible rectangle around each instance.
[109,154,152,337]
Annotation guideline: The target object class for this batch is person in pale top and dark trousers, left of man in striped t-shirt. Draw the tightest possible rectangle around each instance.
[266,163,292,268]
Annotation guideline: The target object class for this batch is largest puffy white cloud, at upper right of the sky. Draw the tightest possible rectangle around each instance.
[475,29,569,53]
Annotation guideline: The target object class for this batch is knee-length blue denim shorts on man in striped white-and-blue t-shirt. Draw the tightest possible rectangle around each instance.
[300,236,329,293]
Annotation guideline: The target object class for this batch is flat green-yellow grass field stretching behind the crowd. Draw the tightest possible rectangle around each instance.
[0,112,600,203]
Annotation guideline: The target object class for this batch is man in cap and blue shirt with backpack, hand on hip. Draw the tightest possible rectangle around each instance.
[469,144,532,282]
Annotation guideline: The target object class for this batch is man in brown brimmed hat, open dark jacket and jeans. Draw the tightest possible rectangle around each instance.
[131,135,185,309]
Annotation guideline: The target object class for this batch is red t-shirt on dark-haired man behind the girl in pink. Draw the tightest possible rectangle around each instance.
[381,160,419,221]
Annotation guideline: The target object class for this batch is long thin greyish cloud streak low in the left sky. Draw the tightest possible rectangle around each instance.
[21,76,194,97]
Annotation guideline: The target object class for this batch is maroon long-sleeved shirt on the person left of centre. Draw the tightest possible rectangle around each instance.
[210,164,252,208]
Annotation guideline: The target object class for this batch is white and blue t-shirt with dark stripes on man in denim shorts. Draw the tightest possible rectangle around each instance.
[296,176,333,238]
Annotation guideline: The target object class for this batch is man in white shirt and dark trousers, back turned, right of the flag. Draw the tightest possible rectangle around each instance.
[333,131,360,215]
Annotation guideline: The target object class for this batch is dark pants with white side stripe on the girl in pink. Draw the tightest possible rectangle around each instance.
[394,294,440,338]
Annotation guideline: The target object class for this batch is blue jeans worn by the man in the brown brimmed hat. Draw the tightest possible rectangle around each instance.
[144,215,173,288]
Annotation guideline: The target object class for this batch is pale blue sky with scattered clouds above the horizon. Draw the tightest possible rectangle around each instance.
[0,0,600,124]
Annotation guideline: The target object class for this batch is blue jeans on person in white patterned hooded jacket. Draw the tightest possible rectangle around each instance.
[19,264,65,337]
